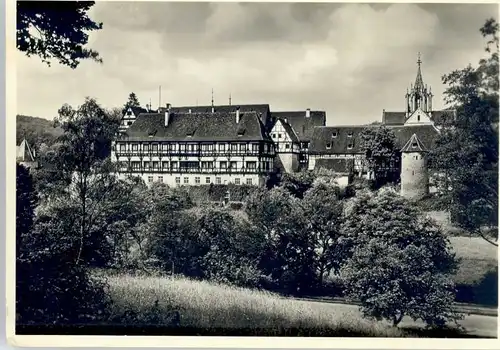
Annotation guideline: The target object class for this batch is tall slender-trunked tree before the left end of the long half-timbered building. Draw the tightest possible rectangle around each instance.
[52,98,119,265]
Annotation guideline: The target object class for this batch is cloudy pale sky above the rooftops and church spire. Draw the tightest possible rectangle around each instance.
[16,2,498,125]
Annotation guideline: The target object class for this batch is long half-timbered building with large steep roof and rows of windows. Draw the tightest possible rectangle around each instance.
[112,107,275,186]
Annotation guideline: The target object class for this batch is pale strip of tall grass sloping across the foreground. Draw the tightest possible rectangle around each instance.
[109,275,403,337]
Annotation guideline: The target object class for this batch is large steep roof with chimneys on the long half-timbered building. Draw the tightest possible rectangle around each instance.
[124,111,270,141]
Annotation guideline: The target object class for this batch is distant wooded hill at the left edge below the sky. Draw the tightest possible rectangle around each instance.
[16,115,63,150]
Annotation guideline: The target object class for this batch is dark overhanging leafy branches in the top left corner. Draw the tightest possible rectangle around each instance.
[17,1,102,69]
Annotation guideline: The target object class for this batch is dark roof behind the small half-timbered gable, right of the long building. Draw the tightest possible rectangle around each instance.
[272,111,326,142]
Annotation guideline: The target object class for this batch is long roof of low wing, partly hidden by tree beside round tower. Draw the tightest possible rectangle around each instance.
[309,124,438,154]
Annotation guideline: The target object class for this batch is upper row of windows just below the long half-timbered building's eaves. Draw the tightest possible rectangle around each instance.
[118,143,272,152]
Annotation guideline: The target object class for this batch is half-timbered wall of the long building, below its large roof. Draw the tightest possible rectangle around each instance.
[112,140,275,186]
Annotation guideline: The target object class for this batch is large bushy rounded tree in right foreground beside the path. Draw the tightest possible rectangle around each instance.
[341,189,459,326]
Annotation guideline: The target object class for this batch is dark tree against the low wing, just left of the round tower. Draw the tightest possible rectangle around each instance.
[360,126,399,186]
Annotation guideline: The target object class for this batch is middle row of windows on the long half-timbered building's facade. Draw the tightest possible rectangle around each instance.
[127,161,270,170]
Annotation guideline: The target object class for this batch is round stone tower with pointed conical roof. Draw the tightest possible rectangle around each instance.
[401,134,429,200]
